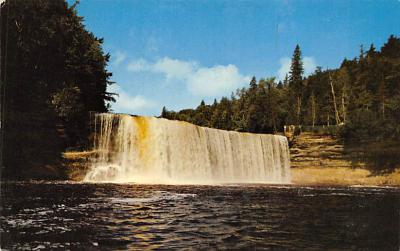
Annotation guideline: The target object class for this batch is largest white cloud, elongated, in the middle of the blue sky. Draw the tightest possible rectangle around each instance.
[128,57,250,96]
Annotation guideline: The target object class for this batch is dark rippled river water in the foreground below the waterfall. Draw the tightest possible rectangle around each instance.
[0,183,400,250]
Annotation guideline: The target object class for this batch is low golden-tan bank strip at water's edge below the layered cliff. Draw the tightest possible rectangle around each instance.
[291,167,400,186]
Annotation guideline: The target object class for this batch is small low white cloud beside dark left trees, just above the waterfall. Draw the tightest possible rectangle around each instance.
[108,84,156,114]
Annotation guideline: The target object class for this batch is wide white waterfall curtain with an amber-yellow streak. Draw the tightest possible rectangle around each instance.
[85,113,290,184]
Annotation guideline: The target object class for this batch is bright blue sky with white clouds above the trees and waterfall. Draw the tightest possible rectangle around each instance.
[69,0,400,115]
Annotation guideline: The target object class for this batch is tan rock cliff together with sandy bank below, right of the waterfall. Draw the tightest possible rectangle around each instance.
[290,132,400,186]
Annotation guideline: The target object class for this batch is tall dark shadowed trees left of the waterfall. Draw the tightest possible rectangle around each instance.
[1,0,113,176]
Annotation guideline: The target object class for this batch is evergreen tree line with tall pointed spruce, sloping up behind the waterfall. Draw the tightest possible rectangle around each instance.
[161,35,400,141]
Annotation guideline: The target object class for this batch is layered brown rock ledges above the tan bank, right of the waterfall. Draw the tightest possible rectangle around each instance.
[290,132,365,168]
